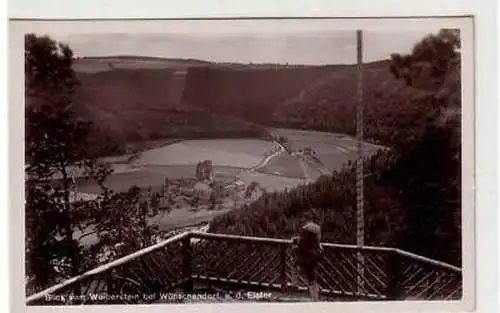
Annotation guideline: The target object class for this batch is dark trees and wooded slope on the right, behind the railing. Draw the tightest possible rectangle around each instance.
[211,30,461,265]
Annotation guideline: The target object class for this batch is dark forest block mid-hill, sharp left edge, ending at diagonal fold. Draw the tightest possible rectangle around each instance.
[182,66,336,124]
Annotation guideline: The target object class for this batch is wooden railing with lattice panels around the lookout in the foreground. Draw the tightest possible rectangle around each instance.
[26,232,462,305]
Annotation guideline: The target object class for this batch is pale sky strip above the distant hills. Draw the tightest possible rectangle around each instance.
[38,25,437,65]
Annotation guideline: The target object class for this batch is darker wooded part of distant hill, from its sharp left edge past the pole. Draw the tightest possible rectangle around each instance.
[183,61,403,130]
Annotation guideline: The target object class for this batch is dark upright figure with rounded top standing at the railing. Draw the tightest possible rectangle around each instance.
[292,222,323,301]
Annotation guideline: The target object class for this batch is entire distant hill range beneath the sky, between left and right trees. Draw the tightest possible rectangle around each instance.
[73,56,401,155]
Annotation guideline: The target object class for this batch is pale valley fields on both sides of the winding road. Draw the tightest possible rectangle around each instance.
[75,129,378,193]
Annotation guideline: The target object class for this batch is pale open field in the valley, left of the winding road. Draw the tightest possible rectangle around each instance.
[78,139,274,193]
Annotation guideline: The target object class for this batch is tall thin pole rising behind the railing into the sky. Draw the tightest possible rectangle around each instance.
[356,30,365,295]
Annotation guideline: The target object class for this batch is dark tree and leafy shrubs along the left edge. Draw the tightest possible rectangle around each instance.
[25,34,161,294]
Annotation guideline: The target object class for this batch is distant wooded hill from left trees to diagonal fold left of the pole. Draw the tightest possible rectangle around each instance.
[73,57,343,154]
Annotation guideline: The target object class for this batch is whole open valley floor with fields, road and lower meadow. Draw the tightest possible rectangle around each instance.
[71,129,380,250]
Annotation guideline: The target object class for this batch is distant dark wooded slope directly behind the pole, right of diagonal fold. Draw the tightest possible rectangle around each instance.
[272,61,403,135]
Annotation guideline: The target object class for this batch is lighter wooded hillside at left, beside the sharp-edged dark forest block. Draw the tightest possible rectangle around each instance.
[74,68,265,154]
